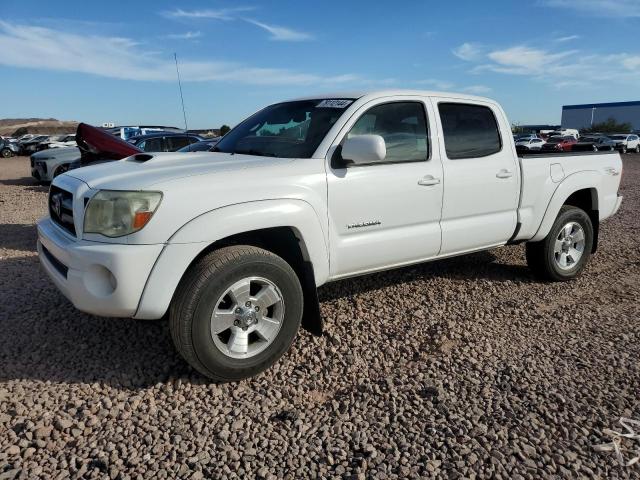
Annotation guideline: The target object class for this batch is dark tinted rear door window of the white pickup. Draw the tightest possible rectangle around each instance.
[438,103,502,160]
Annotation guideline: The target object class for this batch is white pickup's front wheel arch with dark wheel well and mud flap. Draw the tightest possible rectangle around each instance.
[134,200,329,334]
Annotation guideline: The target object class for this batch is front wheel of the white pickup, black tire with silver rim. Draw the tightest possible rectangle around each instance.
[169,245,303,382]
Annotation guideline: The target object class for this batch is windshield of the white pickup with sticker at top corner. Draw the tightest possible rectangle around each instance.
[212,98,354,158]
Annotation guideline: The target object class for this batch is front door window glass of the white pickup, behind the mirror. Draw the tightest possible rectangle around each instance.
[347,102,429,162]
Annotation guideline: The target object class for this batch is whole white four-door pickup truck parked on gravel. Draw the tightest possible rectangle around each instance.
[38,90,622,381]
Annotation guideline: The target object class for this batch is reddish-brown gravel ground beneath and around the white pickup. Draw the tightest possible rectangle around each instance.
[0,155,640,480]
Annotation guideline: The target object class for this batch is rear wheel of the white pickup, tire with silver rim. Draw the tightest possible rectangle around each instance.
[526,205,593,282]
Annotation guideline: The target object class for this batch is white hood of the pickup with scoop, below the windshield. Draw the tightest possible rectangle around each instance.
[65,152,292,190]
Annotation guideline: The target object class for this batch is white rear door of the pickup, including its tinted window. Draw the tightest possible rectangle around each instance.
[433,98,520,255]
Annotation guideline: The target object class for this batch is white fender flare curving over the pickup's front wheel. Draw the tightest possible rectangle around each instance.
[134,199,329,319]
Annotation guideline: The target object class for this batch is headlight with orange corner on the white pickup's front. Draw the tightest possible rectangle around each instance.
[84,190,162,237]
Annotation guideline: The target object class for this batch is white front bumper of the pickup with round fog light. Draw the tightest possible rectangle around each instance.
[38,218,164,317]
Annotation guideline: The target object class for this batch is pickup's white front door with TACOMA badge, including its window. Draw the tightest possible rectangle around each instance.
[327,97,444,278]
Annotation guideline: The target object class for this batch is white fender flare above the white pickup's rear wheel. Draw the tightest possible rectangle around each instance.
[529,170,601,242]
